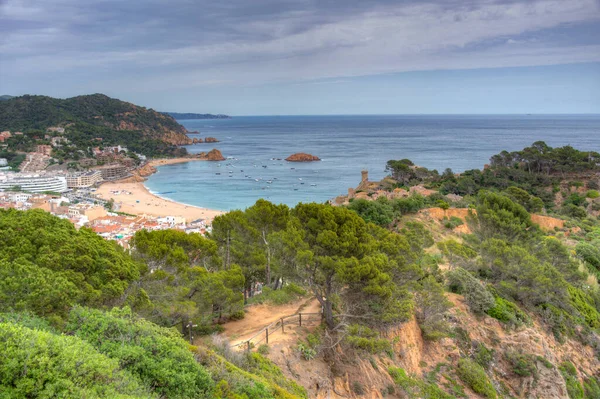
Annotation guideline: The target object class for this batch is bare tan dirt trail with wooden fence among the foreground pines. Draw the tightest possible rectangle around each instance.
[223,298,321,345]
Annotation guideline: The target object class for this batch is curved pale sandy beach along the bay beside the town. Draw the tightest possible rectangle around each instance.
[96,158,225,222]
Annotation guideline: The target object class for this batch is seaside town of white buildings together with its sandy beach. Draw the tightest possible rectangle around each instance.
[0,127,220,248]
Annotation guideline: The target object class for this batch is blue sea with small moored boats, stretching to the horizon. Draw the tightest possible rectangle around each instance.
[145,114,600,211]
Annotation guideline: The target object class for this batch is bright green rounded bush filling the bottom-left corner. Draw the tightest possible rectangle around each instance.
[0,323,154,399]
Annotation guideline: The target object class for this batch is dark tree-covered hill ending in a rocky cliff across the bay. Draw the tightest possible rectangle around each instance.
[0,94,190,145]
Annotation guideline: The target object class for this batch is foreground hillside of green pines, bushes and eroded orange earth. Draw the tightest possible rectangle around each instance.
[0,142,600,399]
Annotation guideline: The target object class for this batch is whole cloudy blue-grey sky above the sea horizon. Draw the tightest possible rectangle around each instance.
[0,0,600,115]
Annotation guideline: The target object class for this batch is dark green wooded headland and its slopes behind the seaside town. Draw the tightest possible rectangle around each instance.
[0,94,191,156]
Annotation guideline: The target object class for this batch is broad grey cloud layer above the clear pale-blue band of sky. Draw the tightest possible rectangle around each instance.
[0,0,600,93]
